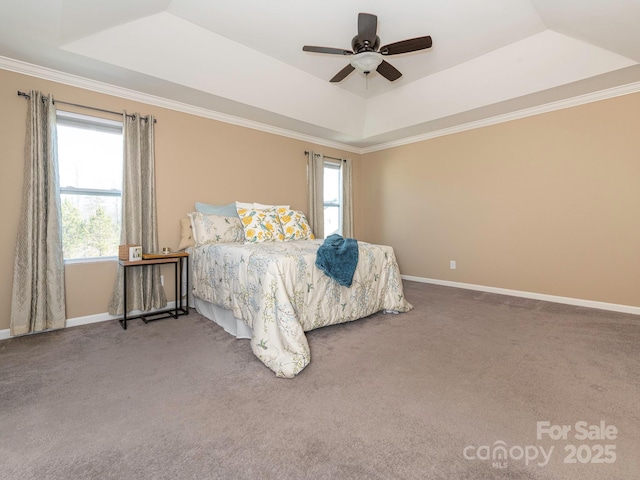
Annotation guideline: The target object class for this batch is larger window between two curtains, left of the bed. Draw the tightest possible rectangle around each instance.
[57,111,123,260]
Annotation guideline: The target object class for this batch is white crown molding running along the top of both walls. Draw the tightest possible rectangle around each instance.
[0,56,640,155]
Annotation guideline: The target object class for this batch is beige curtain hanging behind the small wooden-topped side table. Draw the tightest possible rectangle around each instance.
[109,112,167,315]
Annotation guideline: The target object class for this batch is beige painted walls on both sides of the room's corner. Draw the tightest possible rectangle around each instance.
[0,70,640,329]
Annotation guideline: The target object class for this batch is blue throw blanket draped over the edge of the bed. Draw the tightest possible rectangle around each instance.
[316,234,358,287]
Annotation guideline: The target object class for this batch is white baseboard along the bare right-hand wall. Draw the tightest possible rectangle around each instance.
[401,275,640,315]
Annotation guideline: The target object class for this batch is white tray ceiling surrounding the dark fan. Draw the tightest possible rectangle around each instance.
[0,0,640,148]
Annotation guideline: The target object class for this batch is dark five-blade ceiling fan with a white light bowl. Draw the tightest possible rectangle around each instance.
[302,13,432,82]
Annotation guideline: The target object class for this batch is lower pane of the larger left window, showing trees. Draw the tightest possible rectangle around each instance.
[60,194,121,259]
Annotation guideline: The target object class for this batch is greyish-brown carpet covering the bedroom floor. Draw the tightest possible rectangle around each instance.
[0,282,640,480]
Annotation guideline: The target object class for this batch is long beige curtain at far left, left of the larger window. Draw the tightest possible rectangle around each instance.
[10,91,66,335]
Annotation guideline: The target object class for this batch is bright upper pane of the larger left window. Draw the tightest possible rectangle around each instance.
[58,124,122,191]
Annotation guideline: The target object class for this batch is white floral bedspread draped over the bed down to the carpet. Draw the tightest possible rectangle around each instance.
[192,240,413,378]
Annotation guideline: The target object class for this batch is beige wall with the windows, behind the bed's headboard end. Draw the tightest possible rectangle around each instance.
[0,70,360,330]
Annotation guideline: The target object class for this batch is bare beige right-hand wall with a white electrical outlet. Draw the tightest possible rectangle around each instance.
[360,94,640,306]
